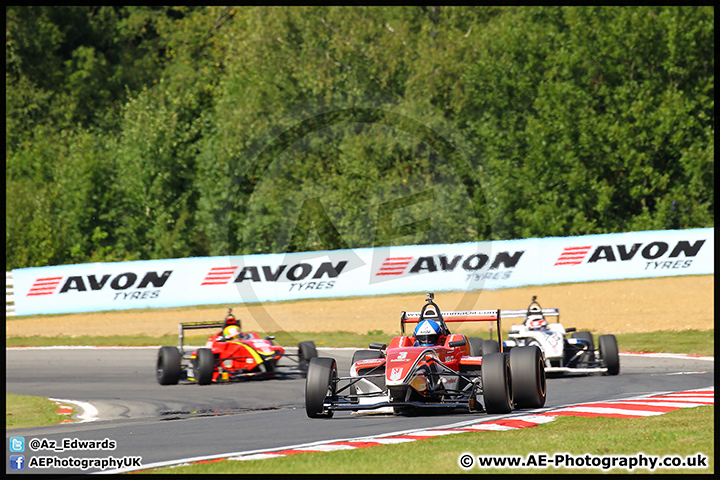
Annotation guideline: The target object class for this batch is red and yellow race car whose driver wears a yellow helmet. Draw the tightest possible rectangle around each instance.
[157,309,317,385]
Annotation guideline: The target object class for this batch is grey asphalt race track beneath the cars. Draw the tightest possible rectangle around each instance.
[5,347,715,474]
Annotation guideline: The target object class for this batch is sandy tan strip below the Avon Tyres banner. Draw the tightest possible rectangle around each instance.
[5,275,714,337]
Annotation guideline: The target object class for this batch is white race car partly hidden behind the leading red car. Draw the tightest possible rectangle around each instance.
[501,296,620,375]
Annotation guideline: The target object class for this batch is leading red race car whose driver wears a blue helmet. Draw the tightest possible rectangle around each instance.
[305,293,546,418]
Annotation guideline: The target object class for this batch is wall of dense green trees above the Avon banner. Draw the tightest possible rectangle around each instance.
[5,6,715,268]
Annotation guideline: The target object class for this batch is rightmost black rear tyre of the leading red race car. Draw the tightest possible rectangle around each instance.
[510,346,546,408]
